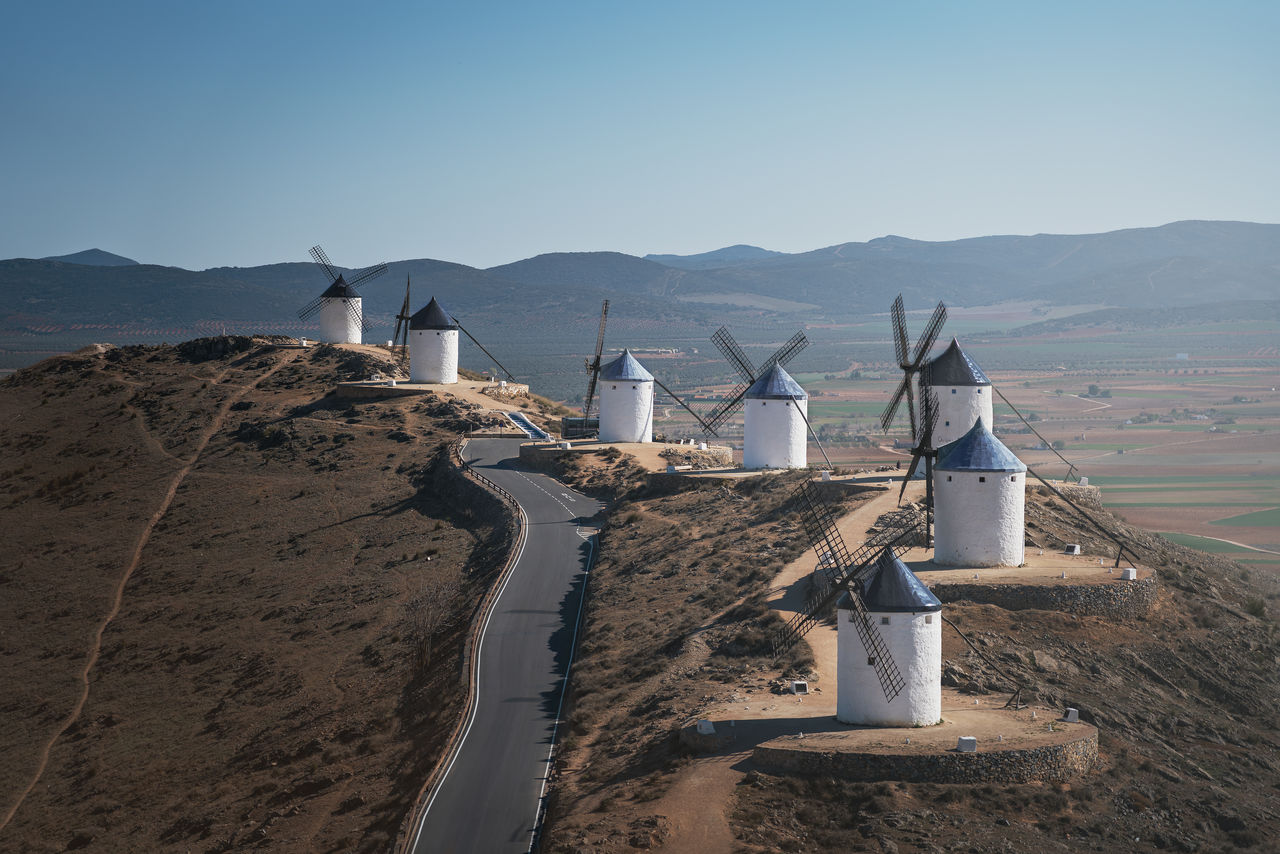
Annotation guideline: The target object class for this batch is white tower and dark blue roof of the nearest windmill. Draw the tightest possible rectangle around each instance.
[836,549,942,726]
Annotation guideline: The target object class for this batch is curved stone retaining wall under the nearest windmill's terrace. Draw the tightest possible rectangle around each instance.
[751,727,1098,784]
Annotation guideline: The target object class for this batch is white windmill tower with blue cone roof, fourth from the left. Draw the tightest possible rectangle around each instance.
[742,364,809,469]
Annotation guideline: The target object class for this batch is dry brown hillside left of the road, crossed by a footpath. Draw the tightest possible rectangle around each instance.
[0,338,511,851]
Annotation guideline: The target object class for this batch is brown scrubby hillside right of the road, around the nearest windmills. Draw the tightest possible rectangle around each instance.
[544,460,1280,854]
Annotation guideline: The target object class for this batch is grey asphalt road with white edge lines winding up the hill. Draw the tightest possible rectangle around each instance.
[412,439,602,854]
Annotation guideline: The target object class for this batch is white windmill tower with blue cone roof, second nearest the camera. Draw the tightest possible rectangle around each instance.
[933,420,1027,566]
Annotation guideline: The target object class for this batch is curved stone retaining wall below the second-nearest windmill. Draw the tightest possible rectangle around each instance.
[929,576,1158,618]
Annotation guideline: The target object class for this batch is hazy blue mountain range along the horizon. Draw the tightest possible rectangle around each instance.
[0,222,1280,353]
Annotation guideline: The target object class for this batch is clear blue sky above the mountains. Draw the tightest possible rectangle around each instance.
[0,0,1280,269]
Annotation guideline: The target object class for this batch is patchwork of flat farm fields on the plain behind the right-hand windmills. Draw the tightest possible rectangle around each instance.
[655,306,1280,572]
